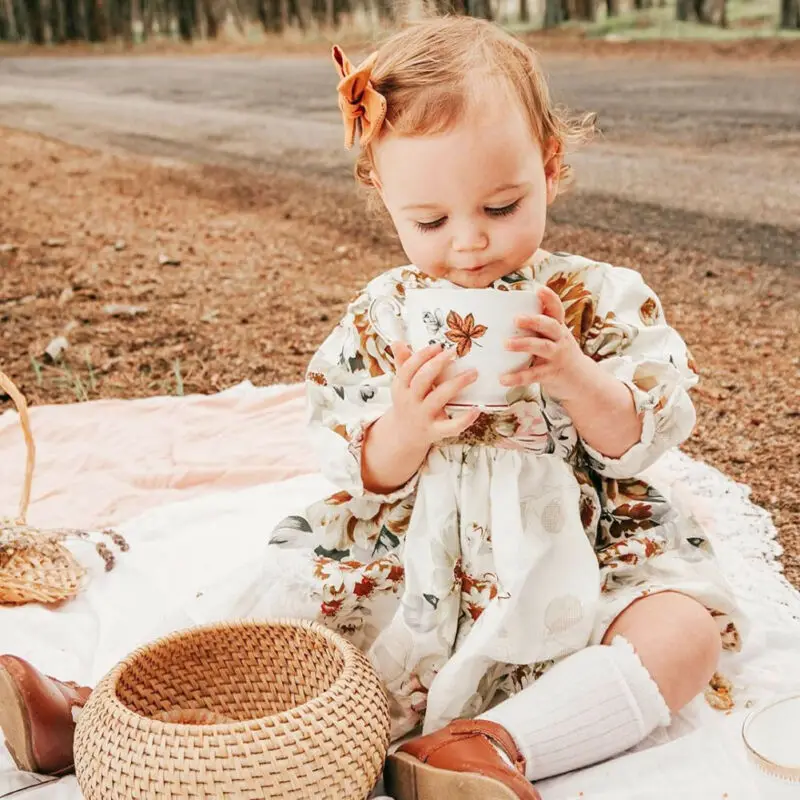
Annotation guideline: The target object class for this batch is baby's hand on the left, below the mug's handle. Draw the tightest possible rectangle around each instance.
[392,342,480,446]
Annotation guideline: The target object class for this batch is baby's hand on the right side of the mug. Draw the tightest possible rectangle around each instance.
[502,287,594,401]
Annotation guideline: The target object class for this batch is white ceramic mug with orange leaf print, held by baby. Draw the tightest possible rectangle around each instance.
[368,288,541,409]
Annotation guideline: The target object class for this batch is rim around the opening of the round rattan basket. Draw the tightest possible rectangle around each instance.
[93,618,376,734]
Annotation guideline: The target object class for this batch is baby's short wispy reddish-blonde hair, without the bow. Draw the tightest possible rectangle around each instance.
[355,16,595,194]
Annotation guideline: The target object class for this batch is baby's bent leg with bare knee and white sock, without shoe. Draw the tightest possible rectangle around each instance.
[482,592,720,780]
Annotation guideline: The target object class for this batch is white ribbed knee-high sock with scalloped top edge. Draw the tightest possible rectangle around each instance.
[481,636,670,781]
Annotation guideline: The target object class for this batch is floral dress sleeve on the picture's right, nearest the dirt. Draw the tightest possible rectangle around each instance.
[581,265,697,478]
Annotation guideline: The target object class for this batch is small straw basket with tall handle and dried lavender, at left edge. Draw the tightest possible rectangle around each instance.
[0,372,128,605]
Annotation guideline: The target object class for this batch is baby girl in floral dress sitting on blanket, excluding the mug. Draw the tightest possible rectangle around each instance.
[272,17,738,800]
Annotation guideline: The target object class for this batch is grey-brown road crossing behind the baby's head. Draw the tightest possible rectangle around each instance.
[0,55,800,264]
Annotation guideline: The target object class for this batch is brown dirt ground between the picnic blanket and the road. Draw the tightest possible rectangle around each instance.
[0,129,800,586]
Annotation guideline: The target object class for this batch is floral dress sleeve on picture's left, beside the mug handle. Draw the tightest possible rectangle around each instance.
[306,276,417,503]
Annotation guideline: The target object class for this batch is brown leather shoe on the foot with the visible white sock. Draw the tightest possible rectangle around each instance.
[384,719,541,800]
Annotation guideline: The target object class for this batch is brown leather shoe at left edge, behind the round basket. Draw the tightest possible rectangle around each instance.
[0,656,92,775]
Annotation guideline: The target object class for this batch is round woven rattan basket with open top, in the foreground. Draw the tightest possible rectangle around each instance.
[75,621,389,800]
